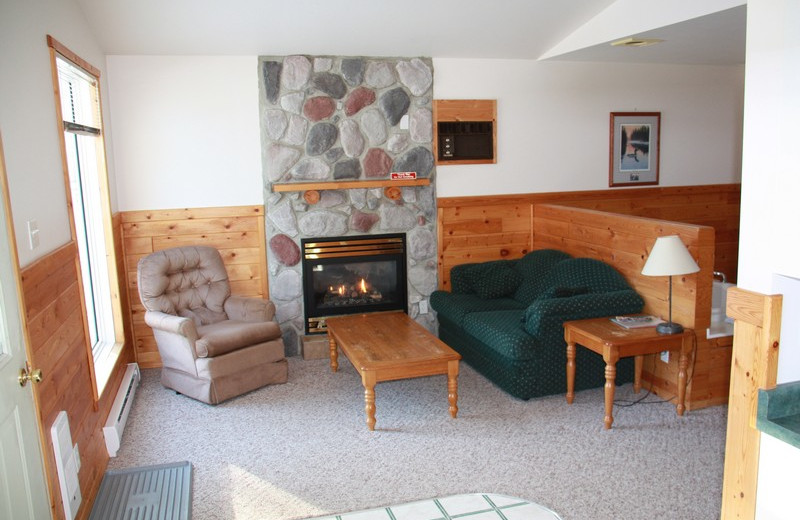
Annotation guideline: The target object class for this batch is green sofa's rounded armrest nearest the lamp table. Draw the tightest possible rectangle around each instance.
[523,289,644,336]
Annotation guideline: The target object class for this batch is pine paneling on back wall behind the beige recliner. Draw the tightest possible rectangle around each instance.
[119,206,269,368]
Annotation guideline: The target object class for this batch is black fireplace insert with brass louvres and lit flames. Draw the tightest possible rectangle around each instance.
[301,233,408,334]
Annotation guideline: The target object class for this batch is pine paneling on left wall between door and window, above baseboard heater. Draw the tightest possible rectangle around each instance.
[21,242,133,519]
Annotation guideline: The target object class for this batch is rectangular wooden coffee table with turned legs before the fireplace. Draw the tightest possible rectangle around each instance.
[326,312,461,430]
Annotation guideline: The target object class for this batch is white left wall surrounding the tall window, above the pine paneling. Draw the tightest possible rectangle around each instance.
[0,0,116,267]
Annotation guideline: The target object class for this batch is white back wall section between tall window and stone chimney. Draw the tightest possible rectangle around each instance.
[107,56,264,211]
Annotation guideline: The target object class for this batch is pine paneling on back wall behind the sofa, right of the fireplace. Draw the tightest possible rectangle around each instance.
[437,184,741,289]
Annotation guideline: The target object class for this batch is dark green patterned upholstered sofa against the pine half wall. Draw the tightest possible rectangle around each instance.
[430,249,644,399]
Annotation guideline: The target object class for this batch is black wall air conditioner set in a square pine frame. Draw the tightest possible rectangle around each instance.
[433,99,497,165]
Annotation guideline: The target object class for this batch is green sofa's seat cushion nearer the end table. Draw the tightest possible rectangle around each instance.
[463,310,537,360]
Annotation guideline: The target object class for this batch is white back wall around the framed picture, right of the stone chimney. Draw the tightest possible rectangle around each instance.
[433,58,744,197]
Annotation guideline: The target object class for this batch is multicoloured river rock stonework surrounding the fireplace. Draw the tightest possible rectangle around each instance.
[259,55,438,356]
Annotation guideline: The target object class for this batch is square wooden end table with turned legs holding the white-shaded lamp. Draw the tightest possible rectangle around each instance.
[564,318,694,429]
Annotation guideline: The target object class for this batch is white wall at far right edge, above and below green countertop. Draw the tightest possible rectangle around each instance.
[738,0,800,520]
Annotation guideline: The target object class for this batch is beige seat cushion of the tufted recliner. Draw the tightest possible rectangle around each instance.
[195,320,281,357]
